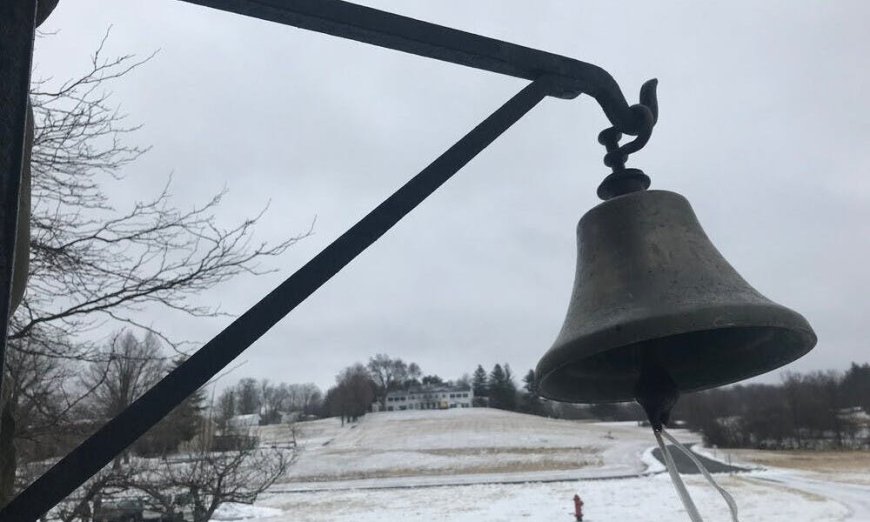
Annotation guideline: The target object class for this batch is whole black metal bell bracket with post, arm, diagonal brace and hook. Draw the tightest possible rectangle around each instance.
[0,0,658,522]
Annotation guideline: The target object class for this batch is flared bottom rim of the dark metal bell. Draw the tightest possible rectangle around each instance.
[535,302,818,403]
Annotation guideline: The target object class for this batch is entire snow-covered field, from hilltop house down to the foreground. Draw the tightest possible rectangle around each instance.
[227,409,870,522]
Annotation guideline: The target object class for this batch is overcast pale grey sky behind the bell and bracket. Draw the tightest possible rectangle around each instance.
[30,0,870,388]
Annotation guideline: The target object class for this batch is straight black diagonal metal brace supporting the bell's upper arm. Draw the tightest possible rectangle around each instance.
[0,79,551,522]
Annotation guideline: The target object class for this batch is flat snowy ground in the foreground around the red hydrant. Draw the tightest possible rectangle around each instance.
[244,475,848,522]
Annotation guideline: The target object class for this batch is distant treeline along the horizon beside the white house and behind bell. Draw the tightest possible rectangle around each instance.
[223,354,870,449]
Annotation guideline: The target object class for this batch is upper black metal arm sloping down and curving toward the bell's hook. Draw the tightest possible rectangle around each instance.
[182,0,638,136]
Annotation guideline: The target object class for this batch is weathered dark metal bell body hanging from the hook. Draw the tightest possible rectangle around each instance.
[536,190,816,402]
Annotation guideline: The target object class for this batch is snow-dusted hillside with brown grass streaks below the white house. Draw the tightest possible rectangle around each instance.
[264,408,697,489]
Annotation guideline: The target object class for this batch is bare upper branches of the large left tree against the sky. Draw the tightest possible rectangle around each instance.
[10,29,305,357]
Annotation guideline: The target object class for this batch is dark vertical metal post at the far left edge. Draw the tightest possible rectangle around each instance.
[0,0,36,430]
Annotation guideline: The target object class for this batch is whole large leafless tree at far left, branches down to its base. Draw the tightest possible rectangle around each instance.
[0,32,310,505]
